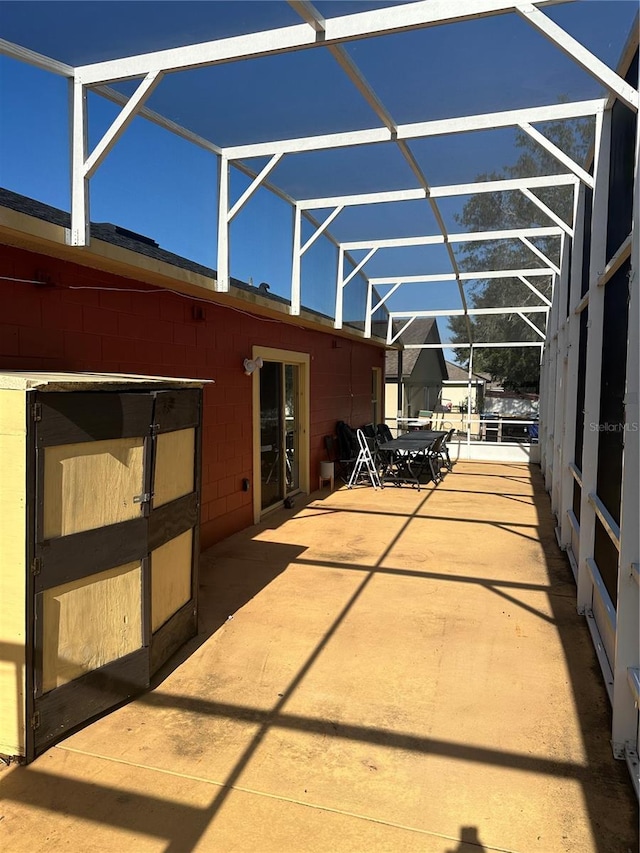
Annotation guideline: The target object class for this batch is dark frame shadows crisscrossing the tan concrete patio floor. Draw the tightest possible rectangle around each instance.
[2,472,637,853]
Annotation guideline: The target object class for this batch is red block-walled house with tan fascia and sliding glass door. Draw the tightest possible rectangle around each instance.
[0,189,385,548]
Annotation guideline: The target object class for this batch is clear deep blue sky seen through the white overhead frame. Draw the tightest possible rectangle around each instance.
[0,0,637,322]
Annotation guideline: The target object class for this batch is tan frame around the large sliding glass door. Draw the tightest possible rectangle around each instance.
[251,346,311,524]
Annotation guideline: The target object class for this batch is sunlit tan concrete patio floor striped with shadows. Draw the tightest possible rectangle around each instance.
[0,463,638,853]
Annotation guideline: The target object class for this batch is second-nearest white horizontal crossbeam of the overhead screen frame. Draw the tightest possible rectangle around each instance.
[225,99,605,160]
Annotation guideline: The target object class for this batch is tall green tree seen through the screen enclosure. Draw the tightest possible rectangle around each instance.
[449,120,593,392]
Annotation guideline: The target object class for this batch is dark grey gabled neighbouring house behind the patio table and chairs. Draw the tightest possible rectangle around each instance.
[385,318,447,422]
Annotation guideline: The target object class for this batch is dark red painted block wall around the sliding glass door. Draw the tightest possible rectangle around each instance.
[0,246,384,548]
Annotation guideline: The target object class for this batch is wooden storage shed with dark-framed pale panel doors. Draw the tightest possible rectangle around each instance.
[0,372,203,761]
